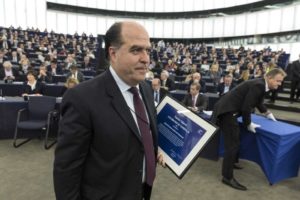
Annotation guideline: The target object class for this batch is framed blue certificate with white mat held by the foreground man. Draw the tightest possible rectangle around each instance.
[157,96,217,179]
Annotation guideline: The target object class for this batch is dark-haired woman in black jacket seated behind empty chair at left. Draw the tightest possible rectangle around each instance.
[22,71,44,96]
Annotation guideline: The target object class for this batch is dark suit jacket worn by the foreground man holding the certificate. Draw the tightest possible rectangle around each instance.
[54,70,157,200]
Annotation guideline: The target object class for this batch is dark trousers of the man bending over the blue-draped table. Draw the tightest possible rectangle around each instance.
[218,113,240,179]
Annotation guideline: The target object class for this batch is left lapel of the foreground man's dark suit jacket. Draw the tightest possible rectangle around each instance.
[105,70,142,142]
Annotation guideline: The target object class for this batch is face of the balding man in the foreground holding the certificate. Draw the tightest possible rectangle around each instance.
[109,23,151,86]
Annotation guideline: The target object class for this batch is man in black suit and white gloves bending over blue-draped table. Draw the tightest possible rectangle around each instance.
[212,68,286,190]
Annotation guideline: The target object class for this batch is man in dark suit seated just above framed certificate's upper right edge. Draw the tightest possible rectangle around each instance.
[182,83,208,113]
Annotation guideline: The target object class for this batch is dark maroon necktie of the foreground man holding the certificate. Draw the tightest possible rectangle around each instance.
[129,87,155,186]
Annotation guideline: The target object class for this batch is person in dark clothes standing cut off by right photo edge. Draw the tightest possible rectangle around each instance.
[290,55,300,103]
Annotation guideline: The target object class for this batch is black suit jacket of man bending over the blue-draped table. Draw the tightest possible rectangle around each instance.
[212,78,267,126]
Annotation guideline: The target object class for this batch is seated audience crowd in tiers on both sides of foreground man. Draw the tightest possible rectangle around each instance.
[0,27,288,103]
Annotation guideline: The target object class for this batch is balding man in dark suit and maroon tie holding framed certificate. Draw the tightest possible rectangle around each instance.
[54,22,164,200]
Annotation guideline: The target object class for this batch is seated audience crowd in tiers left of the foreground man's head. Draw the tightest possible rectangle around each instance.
[0,27,97,82]
